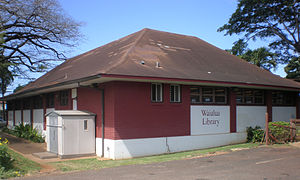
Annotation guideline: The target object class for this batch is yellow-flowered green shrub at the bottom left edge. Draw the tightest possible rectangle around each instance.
[0,138,14,171]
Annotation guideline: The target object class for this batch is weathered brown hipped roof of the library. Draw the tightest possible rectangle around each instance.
[12,29,300,94]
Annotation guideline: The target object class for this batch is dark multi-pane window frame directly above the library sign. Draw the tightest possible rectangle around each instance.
[190,86,228,105]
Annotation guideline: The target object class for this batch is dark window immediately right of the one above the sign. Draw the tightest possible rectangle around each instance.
[236,89,264,104]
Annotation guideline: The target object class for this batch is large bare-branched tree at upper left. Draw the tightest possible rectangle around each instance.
[0,0,81,74]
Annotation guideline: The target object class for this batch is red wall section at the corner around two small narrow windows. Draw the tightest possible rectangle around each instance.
[110,82,190,139]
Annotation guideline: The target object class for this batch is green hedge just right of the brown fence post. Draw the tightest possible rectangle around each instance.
[269,121,290,142]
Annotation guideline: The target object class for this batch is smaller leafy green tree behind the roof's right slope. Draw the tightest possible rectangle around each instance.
[227,40,278,71]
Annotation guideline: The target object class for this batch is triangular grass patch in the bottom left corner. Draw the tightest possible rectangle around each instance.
[0,148,41,179]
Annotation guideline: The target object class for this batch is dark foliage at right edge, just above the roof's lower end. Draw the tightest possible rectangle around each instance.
[284,57,300,81]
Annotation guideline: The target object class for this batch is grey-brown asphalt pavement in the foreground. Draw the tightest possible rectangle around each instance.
[18,147,300,180]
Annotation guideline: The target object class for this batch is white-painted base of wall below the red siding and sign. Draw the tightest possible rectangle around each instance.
[96,133,247,159]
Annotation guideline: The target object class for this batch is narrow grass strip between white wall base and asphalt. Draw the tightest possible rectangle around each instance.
[50,143,259,171]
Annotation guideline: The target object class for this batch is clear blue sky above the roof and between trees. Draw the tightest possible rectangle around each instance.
[9,0,285,94]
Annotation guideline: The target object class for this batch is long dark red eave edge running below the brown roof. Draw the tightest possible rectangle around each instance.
[1,74,300,100]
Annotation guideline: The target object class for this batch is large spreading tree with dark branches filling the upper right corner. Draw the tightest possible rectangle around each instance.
[218,0,300,63]
